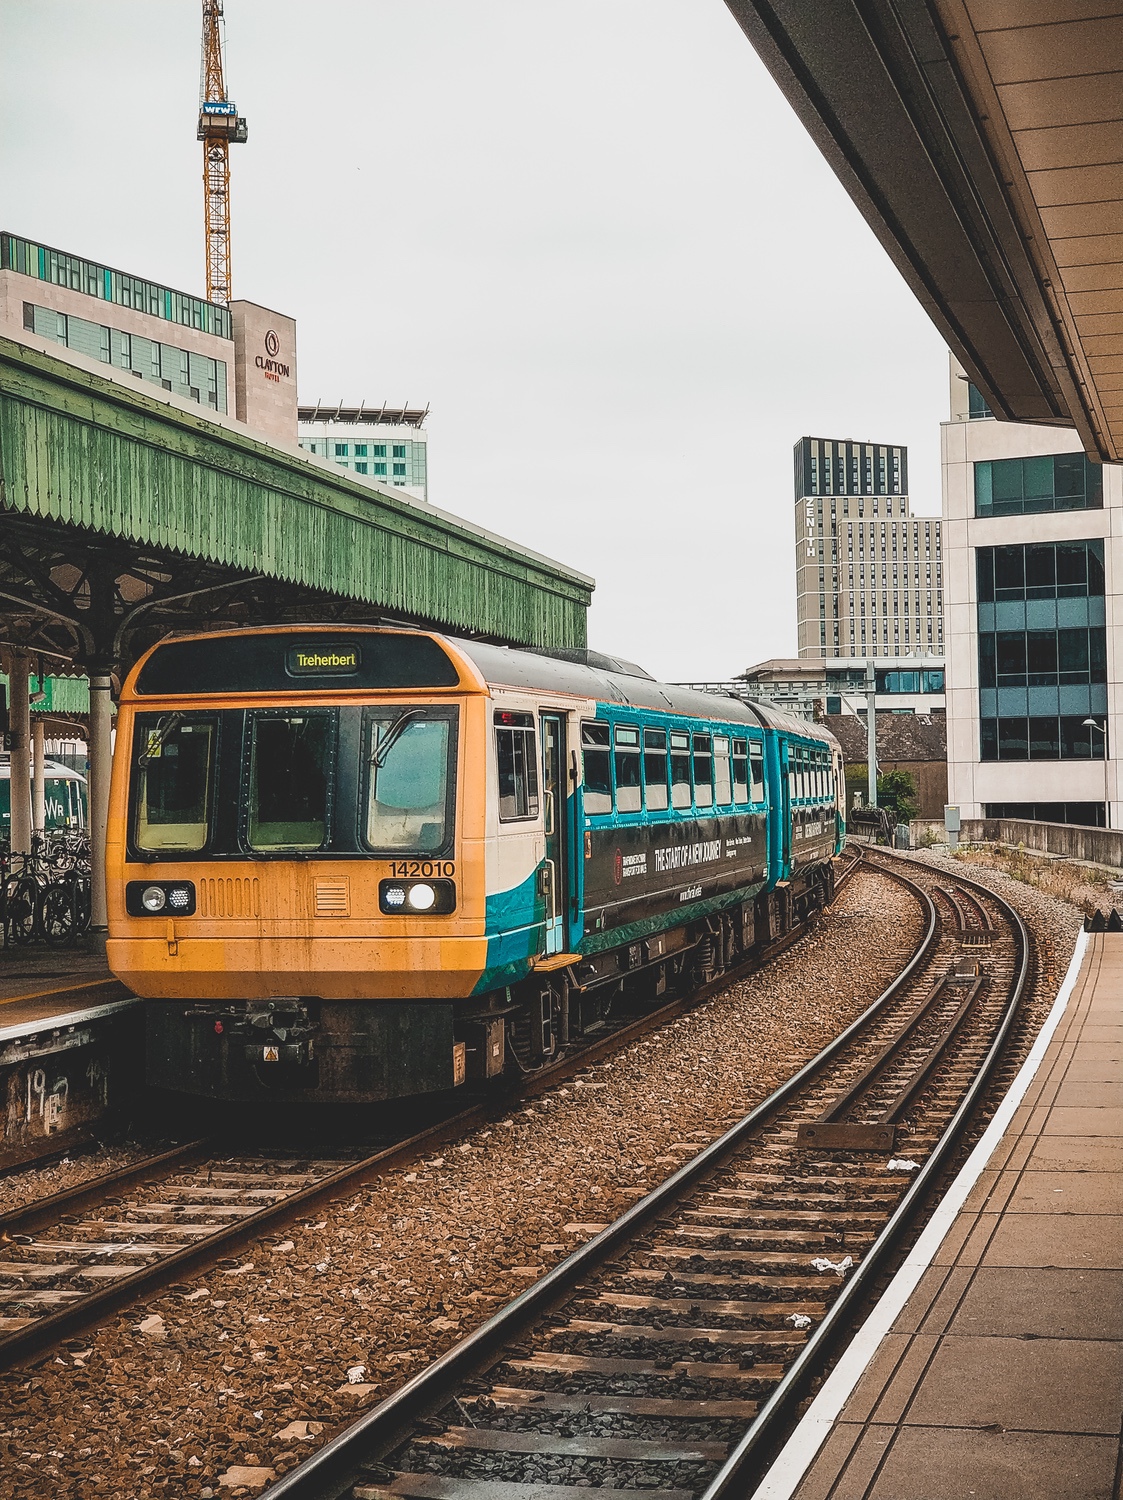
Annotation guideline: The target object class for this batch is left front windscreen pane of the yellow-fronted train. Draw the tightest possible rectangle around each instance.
[133,714,217,854]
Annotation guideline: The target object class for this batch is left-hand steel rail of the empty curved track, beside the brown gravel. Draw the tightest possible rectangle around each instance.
[262,870,940,1500]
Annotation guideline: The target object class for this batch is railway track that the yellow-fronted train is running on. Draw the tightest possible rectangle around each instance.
[0,860,859,1368]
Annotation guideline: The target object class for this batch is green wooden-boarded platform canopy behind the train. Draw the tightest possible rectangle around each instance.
[0,339,592,671]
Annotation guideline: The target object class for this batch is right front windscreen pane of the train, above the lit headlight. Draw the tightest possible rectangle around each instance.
[363,705,455,854]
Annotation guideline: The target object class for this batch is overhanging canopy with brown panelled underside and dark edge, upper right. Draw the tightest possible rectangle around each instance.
[726,0,1123,462]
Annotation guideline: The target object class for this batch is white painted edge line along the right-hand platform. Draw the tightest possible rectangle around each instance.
[753,932,1089,1500]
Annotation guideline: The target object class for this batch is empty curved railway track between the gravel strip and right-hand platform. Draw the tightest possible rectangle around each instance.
[257,851,1033,1500]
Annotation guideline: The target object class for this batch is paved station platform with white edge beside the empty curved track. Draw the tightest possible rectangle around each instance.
[754,933,1123,1500]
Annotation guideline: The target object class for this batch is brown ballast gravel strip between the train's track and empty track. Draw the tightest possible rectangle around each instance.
[0,873,1075,1500]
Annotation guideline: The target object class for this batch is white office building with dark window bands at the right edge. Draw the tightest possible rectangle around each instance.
[943,362,1123,828]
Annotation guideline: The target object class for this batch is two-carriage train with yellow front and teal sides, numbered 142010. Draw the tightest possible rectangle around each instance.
[106,624,846,1104]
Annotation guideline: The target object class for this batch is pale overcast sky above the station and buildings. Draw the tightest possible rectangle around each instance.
[0,0,948,680]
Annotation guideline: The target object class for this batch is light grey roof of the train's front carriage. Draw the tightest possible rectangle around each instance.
[453,641,767,726]
